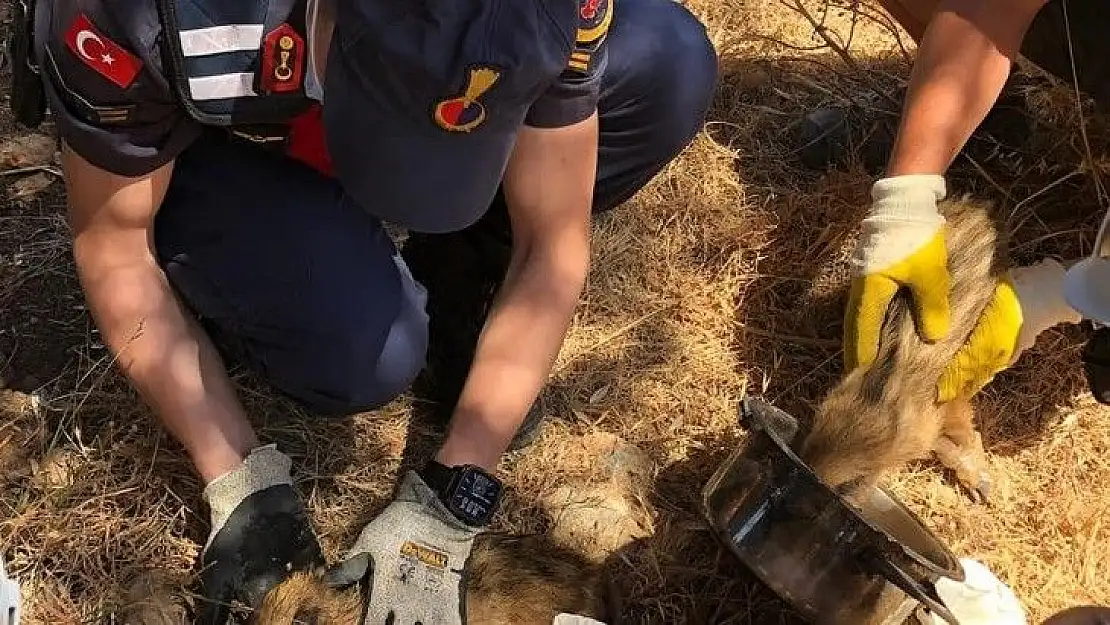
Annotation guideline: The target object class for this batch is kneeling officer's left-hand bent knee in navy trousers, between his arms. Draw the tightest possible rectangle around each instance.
[155,134,427,415]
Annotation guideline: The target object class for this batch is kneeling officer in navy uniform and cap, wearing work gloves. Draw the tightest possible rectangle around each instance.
[23,0,717,624]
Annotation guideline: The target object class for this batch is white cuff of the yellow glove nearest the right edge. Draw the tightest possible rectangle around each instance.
[1010,259,1083,363]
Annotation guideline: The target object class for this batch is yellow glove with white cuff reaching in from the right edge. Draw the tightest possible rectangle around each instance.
[937,260,1082,402]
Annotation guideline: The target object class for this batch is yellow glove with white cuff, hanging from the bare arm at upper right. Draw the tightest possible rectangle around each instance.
[844,174,949,371]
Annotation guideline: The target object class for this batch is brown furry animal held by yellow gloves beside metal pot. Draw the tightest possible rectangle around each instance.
[797,198,1007,501]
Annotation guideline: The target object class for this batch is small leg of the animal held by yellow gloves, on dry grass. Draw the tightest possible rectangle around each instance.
[934,399,992,503]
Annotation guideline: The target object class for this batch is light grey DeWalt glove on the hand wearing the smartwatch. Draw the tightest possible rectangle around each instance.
[324,471,482,625]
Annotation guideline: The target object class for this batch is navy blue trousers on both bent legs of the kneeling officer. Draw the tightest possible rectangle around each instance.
[154,0,717,415]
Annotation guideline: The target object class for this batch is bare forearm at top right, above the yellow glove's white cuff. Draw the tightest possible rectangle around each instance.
[887,0,1042,177]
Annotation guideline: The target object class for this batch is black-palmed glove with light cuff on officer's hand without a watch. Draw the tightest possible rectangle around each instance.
[196,445,324,625]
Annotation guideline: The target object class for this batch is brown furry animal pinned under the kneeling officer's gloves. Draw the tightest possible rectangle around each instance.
[251,533,609,625]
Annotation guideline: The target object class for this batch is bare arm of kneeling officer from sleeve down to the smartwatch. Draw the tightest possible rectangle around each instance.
[436,116,598,470]
